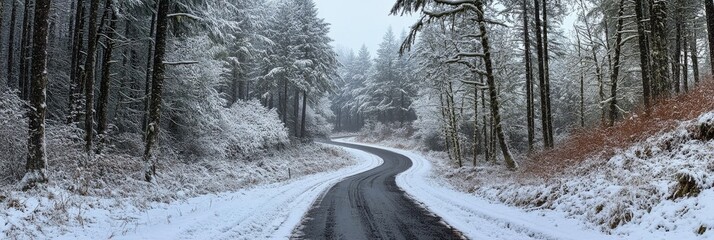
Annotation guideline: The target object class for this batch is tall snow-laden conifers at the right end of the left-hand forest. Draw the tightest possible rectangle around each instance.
[259,0,339,138]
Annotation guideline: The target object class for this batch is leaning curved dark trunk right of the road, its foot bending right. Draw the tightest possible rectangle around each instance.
[476,0,516,169]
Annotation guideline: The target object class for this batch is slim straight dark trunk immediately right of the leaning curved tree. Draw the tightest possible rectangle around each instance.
[523,0,535,153]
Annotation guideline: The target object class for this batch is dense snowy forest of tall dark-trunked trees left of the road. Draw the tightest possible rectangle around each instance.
[0,0,338,188]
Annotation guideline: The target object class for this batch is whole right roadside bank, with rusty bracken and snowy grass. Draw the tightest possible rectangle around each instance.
[348,101,714,239]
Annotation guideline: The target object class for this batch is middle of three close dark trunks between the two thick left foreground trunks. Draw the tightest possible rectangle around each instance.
[84,1,99,154]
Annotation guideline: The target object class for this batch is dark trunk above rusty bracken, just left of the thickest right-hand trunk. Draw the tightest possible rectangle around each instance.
[635,0,652,109]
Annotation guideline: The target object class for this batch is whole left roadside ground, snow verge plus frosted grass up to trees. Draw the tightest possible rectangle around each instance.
[0,144,362,239]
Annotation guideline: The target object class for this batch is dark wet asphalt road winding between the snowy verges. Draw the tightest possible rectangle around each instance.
[293,142,463,239]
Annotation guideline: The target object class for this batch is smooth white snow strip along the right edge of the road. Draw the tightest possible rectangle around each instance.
[338,138,612,239]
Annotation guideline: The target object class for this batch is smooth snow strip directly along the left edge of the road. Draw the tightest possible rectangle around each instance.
[54,148,382,239]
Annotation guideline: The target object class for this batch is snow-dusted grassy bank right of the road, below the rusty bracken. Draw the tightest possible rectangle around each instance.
[432,113,714,239]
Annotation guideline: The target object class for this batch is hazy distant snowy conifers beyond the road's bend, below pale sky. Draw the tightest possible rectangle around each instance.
[331,28,418,131]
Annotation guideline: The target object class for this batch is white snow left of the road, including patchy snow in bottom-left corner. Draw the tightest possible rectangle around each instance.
[0,146,382,239]
